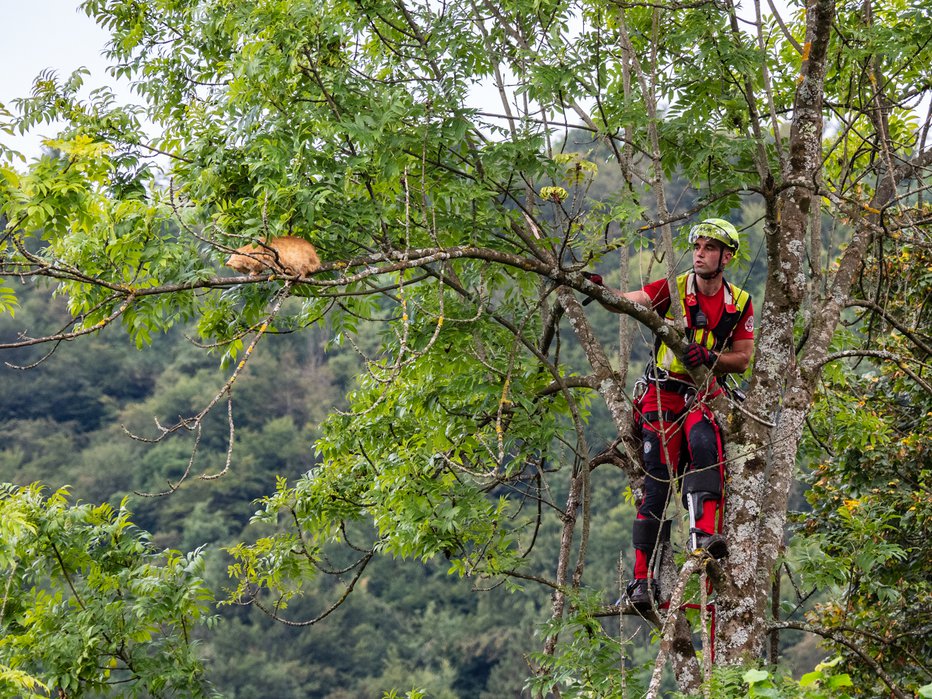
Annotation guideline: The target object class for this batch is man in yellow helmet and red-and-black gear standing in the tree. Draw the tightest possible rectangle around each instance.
[608,218,754,607]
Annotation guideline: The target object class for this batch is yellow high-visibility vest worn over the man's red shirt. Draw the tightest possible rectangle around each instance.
[654,272,751,374]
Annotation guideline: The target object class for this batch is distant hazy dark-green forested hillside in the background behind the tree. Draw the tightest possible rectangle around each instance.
[0,276,660,699]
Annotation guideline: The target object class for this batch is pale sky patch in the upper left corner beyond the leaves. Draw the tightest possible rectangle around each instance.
[0,0,118,157]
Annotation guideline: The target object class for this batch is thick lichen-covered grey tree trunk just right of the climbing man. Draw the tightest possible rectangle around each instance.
[718,0,835,663]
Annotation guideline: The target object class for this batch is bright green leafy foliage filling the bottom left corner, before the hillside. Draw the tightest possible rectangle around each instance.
[0,485,212,696]
